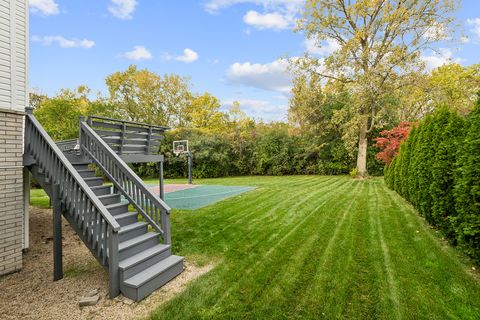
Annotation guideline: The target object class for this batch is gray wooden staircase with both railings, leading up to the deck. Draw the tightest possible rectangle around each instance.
[25,108,183,301]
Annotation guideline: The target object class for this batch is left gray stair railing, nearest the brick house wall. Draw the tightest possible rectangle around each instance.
[25,110,120,298]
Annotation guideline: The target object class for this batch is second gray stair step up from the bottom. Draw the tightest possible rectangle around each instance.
[118,244,172,280]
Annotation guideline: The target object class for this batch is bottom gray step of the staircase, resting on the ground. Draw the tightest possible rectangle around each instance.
[121,255,183,301]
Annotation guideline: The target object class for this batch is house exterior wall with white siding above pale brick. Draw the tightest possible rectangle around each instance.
[0,0,28,275]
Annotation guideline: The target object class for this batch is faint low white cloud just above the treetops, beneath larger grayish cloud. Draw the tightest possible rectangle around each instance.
[222,99,288,121]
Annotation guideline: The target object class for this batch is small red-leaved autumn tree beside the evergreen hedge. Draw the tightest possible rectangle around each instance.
[373,122,414,165]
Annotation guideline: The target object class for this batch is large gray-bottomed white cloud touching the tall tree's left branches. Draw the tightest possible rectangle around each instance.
[227,59,292,93]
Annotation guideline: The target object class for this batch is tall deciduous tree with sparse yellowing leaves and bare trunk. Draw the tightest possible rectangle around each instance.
[295,0,456,176]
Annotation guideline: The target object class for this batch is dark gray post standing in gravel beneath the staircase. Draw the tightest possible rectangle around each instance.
[51,184,63,281]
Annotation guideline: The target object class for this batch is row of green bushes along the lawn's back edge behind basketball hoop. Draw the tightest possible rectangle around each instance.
[134,127,383,178]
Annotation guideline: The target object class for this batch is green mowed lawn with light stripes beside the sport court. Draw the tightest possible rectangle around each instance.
[29,176,480,319]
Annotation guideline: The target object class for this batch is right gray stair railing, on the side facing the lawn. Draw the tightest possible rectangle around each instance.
[80,119,171,244]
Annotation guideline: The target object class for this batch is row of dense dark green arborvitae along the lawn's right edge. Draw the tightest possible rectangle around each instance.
[385,106,480,262]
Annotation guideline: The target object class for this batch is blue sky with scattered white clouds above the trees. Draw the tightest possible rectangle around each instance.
[30,0,480,121]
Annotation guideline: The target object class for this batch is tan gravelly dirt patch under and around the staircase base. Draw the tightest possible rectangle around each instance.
[0,208,213,320]
